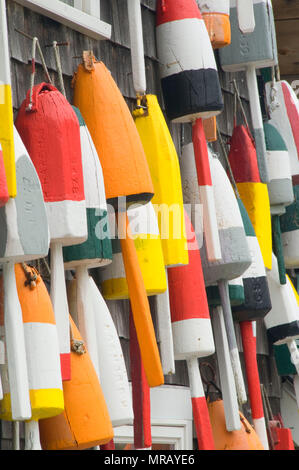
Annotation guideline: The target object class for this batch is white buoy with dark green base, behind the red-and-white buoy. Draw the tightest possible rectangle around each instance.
[63,107,112,270]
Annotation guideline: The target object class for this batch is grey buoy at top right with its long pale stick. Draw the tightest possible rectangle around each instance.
[219,0,277,183]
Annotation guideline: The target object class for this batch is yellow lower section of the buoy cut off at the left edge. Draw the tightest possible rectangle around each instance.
[0,85,17,197]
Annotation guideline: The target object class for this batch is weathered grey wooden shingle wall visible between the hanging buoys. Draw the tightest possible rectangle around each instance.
[2,0,280,448]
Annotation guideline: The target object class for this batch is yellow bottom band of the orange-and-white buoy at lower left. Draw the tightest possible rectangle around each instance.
[0,389,64,421]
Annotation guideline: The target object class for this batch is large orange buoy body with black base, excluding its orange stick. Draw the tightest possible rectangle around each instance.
[74,60,154,208]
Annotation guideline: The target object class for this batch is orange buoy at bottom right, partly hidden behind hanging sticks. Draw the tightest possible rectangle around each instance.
[208,400,264,450]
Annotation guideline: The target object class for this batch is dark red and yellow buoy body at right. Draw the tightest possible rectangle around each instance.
[228,125,272,269]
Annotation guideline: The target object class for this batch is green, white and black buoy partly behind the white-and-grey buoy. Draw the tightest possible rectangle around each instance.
[232,199,272,322]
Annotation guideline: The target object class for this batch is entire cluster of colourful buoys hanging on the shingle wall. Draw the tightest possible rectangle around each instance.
[0,0,299,450]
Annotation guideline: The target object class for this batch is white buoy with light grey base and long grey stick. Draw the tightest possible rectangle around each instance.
[201,153,252,403]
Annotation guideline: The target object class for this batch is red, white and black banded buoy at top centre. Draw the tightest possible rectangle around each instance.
[156,0,223,122]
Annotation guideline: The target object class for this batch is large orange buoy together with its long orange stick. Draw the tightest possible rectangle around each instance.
[74,55,164,387]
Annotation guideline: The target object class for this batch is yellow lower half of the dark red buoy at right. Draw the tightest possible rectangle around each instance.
[237,183,272,270]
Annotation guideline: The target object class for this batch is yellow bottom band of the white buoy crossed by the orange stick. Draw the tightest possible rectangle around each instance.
[102,235,167,300]
